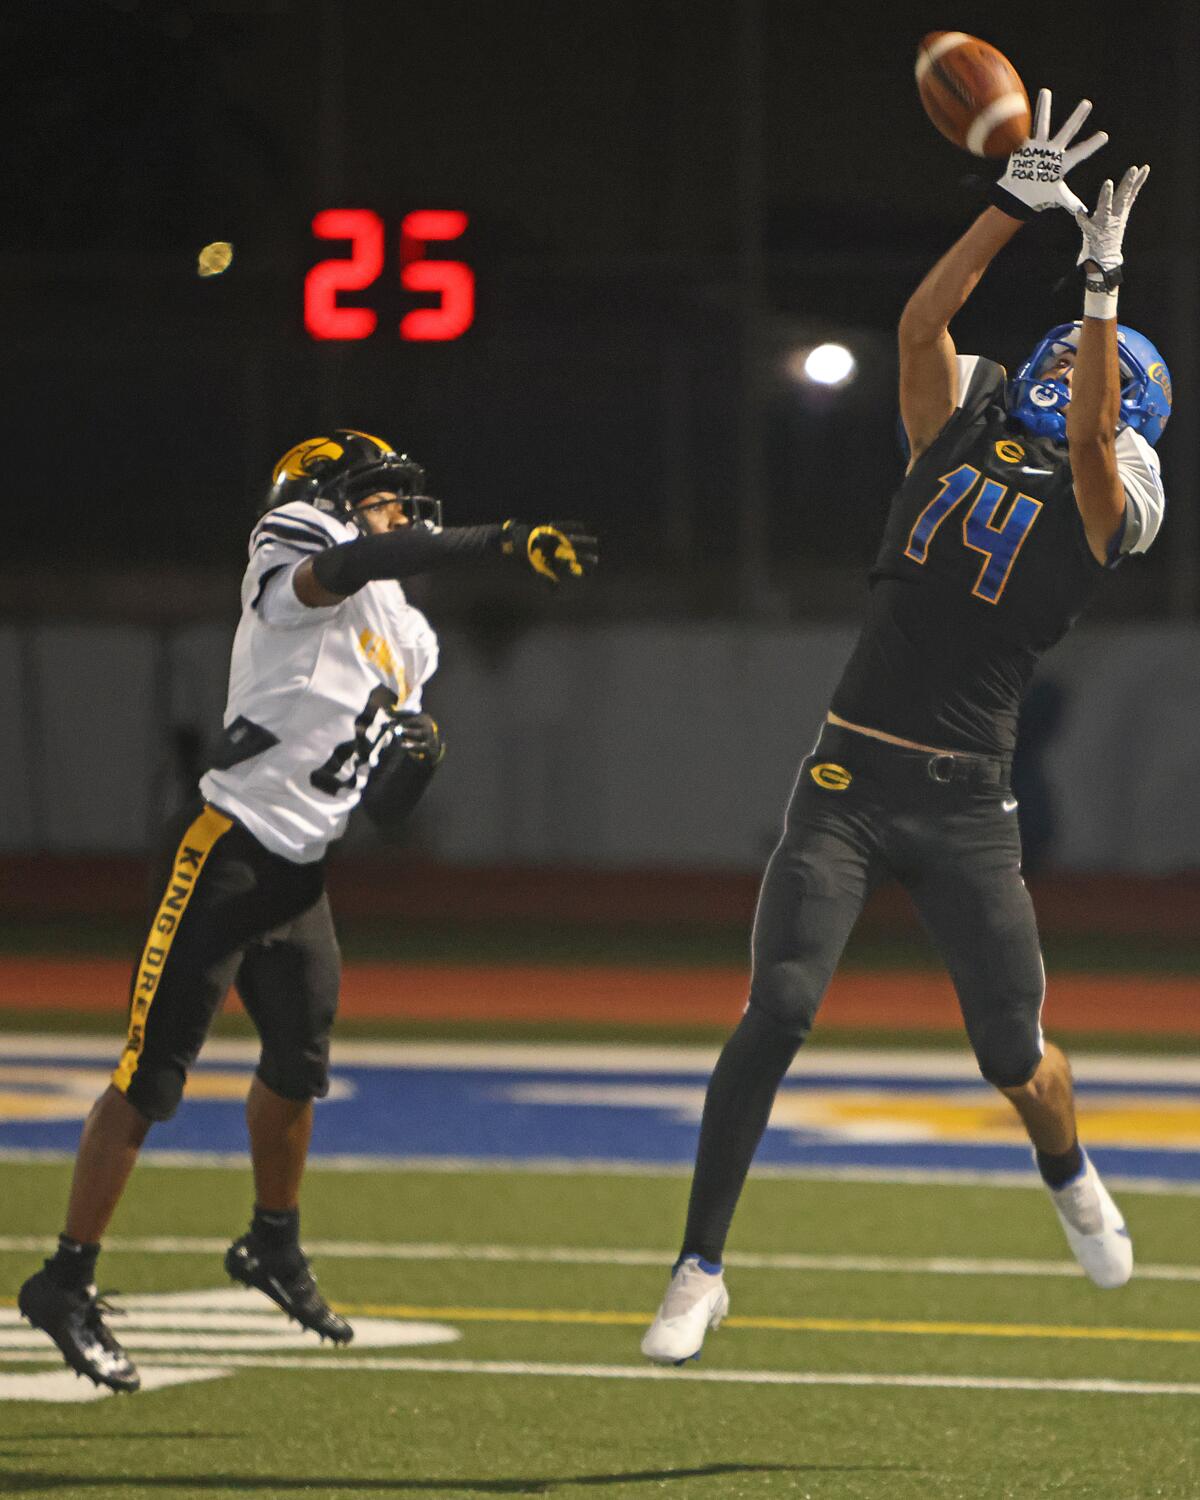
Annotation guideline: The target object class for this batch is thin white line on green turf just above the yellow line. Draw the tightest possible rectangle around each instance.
[0,1235,1200,1281]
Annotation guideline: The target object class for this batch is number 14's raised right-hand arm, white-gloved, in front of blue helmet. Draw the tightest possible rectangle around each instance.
[1067,167,1151,563]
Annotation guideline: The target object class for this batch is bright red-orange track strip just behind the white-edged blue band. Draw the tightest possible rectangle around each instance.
[0,959,1200,1037]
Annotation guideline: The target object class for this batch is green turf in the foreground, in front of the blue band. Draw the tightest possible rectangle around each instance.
[0,1163,1200,1500]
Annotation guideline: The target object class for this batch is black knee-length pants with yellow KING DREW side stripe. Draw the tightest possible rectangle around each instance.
[113,798,341,1121]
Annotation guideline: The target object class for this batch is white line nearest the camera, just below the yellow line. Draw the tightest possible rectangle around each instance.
[0,1352,1200,1397]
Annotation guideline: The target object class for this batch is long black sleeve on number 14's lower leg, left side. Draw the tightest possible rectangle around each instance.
[681,1011,800,1265]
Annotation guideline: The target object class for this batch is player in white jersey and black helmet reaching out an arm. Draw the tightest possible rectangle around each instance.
[18,429,597,1391]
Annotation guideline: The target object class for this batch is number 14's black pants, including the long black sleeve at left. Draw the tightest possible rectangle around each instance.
[684,725,1046,1262]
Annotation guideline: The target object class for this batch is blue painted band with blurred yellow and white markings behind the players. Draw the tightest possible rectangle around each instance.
[0,1038,1200,1184]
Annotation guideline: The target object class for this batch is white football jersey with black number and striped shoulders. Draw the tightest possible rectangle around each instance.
[200,501,438,864]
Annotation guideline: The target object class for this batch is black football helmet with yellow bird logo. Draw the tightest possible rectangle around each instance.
[260,428,441,527]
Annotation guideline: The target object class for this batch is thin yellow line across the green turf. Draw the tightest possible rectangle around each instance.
[338,1302,1200,1344]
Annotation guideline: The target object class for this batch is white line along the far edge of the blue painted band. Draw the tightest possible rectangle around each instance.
[0,1031,1200,1088]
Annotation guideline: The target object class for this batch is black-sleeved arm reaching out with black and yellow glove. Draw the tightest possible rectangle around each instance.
[293,521,599,609]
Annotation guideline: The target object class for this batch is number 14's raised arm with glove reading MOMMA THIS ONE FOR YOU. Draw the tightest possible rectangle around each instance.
[900,89,1109,462]
